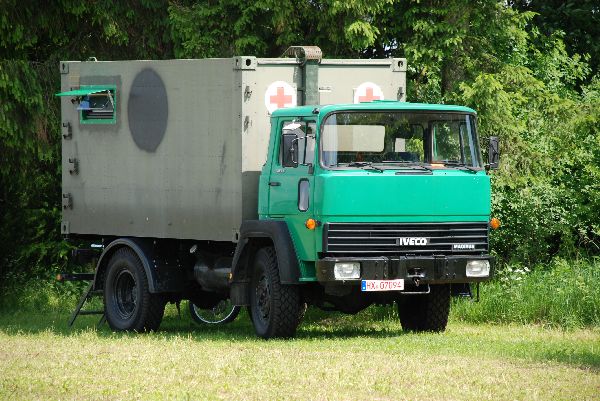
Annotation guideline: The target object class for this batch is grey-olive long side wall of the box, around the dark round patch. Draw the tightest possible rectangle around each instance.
[62,59,243,241]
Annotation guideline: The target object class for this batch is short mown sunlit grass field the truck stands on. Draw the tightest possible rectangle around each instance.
[0,307,600,400]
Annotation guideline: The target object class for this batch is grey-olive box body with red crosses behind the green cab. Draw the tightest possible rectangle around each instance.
[59,57,406,242]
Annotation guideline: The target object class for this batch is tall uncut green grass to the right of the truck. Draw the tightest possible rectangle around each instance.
[453,258,600,328]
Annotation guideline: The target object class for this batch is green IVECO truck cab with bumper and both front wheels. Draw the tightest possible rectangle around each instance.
[227,101,493,337]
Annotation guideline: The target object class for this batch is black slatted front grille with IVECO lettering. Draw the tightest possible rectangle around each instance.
[323,222,488,256]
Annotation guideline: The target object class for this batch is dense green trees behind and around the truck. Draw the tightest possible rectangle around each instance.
[0,0,600,286]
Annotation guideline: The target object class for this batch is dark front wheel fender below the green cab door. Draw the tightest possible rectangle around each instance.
[231,220,300,284]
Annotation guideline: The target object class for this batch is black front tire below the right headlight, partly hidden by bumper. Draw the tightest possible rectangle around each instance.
[398,284,450,332]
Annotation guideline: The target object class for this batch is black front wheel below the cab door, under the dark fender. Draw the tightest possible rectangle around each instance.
[250,247,304,339]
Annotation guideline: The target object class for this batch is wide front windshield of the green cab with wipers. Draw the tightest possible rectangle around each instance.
[321,111,482,168]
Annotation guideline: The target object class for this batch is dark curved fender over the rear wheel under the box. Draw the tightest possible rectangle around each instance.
[94,238,162,293]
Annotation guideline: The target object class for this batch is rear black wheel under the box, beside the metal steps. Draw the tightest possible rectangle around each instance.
[104,248,165,332]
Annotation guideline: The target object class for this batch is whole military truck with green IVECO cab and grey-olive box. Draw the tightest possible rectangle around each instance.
[57,47,498,338]
